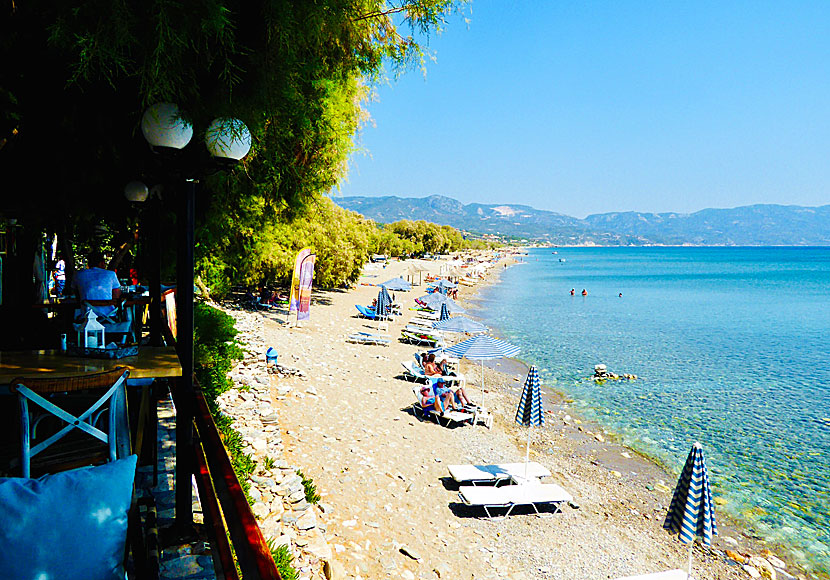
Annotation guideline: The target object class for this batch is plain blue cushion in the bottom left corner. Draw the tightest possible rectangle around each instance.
[0,455,136,580]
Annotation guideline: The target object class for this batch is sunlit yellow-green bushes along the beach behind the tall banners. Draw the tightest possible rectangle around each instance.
[196,196,489,296]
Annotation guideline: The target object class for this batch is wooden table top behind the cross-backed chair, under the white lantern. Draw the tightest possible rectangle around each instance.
[0,346,182,385]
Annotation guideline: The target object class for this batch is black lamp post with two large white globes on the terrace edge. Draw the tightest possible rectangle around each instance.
[141,103,251,533]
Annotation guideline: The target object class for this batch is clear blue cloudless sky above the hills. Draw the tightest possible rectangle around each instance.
[336,0,830,217]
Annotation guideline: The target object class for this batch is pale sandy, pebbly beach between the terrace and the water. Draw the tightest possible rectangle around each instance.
[221,254,803,579]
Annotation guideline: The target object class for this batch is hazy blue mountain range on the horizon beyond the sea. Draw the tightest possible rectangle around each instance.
[333,195,830,246]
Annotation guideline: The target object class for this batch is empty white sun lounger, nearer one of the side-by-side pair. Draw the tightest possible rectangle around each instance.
[458,483,573,519]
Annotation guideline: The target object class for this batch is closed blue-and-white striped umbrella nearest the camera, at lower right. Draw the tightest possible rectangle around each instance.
[663,443,718,578]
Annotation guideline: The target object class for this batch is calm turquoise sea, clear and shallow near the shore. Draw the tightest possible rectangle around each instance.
[481,248,830,573]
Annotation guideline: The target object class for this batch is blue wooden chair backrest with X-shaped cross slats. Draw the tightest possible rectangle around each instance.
[10,367,130,477]
